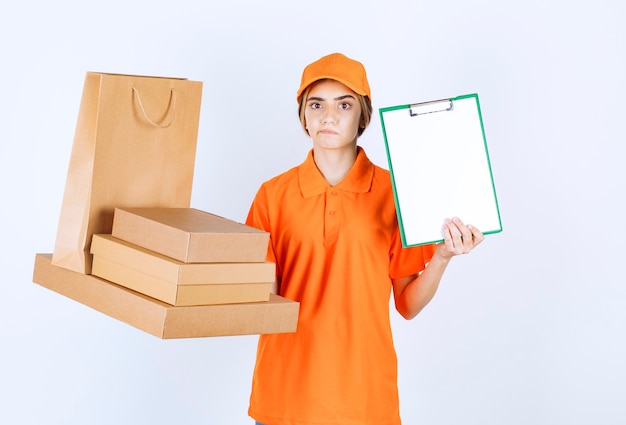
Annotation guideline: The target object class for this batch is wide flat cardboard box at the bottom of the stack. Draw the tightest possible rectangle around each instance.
[33,254,300,339]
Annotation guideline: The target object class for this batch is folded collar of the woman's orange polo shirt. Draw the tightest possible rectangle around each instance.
[298,146,374,198]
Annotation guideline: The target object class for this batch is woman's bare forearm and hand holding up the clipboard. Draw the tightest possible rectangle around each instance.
[392,217,484,320]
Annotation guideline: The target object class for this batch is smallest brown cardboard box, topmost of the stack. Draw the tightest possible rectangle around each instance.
[111,208,269,263]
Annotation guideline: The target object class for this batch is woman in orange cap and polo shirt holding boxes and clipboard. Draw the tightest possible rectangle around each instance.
[246,53,483,425]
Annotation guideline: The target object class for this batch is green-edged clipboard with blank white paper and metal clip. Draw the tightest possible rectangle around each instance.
[379,94,502,247]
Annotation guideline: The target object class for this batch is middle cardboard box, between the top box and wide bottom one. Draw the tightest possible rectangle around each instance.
[91,235,275,306]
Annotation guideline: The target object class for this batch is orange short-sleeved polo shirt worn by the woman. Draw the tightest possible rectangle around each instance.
[246,147,434,425]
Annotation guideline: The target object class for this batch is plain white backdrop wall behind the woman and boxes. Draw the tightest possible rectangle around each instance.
[0,0,626,425]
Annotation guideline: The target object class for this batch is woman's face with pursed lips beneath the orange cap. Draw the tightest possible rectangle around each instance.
[304,80,361,149]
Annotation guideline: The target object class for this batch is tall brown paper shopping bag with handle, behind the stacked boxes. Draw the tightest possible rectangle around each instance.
[52,72,202,274]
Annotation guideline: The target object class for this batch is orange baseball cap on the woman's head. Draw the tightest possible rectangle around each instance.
[296,53,372,103]
